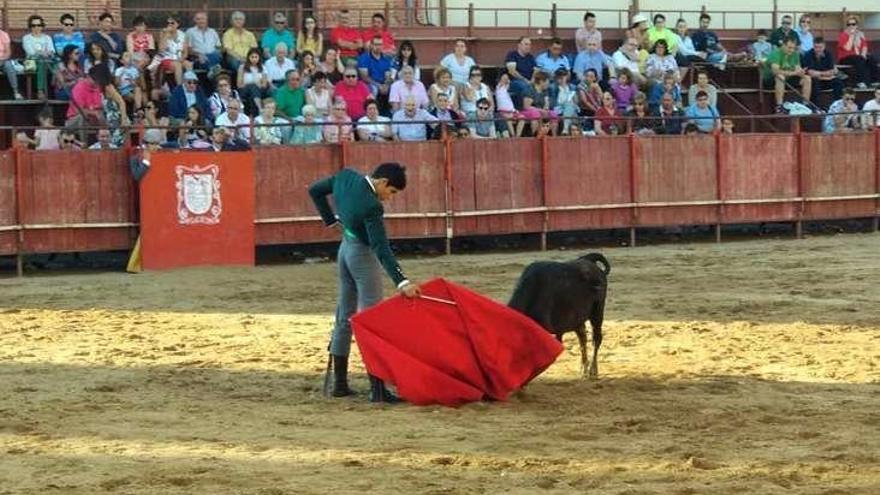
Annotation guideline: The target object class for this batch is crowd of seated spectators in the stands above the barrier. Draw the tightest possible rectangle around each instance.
[0,11,880,149]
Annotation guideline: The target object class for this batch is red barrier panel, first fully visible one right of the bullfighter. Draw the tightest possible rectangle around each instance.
[452,139,543,235]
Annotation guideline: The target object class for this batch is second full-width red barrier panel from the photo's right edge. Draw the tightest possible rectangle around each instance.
[719,134,799,223]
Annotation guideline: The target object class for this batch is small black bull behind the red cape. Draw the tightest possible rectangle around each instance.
[507,253,611,378]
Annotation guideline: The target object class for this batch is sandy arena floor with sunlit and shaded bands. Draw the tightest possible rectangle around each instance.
[0,234,880,495]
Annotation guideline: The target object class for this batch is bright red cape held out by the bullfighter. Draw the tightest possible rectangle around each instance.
[351,278,562,406]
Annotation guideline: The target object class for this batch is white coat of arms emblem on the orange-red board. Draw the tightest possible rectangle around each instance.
[175,165,223,225]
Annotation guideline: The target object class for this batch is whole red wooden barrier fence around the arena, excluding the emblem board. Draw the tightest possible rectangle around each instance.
[0,130,880,272]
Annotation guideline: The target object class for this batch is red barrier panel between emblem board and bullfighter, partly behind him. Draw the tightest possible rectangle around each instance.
[255,145,341,245]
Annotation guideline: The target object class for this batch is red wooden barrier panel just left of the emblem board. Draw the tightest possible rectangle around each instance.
[19,150,136,253]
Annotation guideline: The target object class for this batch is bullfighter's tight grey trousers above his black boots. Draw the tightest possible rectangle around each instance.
[330,234,382,356]
